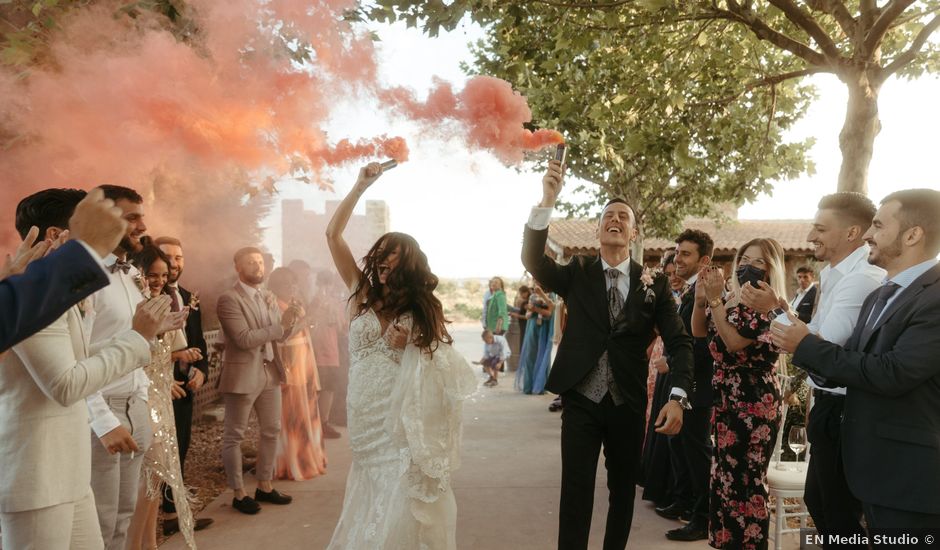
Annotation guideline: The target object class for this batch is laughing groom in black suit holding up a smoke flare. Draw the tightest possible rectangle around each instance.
[522,160,692,550]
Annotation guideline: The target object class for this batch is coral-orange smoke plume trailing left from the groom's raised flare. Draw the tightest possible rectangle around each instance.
[378,76,565,164]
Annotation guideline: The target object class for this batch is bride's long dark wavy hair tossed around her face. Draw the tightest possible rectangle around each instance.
[349,232,454,353]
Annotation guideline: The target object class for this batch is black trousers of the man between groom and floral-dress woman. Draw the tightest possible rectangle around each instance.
[669,407,713,529]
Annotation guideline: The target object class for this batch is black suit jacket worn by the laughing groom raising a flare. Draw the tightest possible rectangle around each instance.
[522,227,692,415]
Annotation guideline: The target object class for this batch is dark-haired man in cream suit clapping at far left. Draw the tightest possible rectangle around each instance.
[0,189,170,550]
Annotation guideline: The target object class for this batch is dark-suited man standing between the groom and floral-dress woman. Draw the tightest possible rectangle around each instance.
[657,229,715,541]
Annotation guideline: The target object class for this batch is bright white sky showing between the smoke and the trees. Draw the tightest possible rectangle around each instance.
[264,19,940,278]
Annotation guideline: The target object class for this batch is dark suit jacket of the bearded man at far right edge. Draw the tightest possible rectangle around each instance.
[793,265,940,514]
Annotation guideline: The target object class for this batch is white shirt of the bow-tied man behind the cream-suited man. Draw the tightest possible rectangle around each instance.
[82,254,150,437]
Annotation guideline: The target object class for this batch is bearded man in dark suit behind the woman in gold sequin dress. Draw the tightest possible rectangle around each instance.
[154,237,212,536]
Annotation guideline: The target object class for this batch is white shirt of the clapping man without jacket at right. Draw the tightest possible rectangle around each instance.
[806,244,885,395]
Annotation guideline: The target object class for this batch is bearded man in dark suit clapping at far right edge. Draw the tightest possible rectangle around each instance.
[772,189,940,530]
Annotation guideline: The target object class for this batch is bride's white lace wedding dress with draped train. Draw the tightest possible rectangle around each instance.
[327,310,477,550]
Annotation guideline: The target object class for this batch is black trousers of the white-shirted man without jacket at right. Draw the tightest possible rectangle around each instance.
[803,390,863,547]
